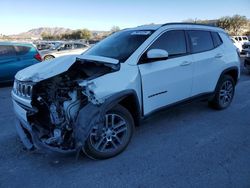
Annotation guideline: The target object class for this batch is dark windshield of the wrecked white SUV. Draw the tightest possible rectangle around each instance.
[85,30,152,62]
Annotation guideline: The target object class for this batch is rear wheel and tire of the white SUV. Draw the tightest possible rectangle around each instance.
[209,75,235,110]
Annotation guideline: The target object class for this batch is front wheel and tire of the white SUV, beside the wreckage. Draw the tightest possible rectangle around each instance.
[84,105,134,159]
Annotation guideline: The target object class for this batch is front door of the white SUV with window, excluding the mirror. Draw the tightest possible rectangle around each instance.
[139,30,193,115]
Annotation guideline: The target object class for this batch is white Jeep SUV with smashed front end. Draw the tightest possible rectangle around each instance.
[12,23,240,159]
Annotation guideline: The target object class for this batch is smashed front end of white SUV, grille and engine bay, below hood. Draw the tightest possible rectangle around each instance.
[12,55,122,153]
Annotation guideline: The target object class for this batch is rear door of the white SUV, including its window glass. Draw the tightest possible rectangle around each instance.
[188,30,224,96]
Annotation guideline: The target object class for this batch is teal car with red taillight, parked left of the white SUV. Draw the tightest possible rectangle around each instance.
[0,42,42,83]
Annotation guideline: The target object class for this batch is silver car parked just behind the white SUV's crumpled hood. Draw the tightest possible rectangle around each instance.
[40,42,88,60]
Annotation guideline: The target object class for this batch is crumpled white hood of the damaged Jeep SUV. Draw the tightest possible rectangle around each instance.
[15,54,119,82]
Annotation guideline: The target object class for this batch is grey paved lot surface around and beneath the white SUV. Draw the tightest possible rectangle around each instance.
[0,60,250,188]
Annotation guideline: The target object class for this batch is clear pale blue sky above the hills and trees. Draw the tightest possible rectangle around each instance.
[0,0,250,35]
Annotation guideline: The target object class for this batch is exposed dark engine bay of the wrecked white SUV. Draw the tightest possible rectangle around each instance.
[23,60,119,151]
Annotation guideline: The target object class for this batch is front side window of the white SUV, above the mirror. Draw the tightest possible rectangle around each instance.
[149,30,187,57]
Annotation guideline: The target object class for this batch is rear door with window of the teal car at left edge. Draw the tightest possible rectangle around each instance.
[0,45,18,82]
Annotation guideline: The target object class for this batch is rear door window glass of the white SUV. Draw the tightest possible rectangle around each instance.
[188,31,214,53]
